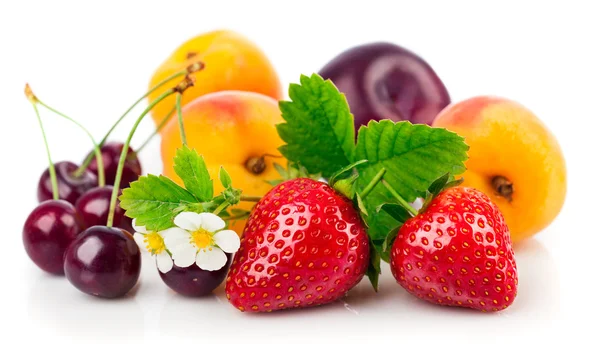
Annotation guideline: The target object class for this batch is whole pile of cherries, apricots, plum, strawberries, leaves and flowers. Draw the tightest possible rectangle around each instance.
[23,31,566,312]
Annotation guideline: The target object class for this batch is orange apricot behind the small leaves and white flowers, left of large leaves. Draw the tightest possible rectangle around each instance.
[161,91,287,235]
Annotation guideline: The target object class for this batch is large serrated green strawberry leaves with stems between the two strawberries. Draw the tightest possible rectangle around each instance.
[277,74,468,287]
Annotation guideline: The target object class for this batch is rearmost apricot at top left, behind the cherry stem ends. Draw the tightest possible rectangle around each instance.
[148,30,282,124]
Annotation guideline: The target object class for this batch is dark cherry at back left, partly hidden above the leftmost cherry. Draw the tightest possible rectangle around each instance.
[38,162,98,204]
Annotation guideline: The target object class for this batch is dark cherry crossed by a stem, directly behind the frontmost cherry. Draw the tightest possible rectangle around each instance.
[75,185,133,233]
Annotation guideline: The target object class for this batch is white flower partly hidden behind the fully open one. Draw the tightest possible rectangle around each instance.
[132,219,181,273]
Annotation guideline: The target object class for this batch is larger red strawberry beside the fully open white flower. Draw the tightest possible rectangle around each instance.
[226,178,369,312]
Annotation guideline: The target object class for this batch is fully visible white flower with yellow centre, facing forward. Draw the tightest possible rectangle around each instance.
[163,212,240,271]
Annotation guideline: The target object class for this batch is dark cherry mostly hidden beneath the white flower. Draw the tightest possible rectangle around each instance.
[159,254,232,297]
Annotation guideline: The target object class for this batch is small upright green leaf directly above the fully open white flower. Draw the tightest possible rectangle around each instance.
[173,146,213,201]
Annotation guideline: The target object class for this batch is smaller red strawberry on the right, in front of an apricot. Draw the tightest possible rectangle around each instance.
[391,187,518,311]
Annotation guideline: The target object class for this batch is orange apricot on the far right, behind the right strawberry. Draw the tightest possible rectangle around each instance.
[432,97,567,243]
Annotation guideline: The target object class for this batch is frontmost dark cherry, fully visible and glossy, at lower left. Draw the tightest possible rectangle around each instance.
[64,226,142,298]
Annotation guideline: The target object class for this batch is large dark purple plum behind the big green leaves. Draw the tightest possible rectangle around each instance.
[319,42,450,130]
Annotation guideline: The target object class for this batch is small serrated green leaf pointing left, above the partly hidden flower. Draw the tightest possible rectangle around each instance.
[119,174,198,231]
